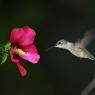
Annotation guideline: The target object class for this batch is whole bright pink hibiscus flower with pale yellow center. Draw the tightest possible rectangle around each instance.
[10,26,40,76]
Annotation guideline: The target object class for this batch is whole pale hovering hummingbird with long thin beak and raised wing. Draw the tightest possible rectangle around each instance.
[48,27,95,60]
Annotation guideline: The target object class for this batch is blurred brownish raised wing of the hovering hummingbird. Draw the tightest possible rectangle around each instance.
[75,27,95,48]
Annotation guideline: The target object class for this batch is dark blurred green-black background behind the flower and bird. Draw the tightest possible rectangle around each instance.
[0,0,95,95]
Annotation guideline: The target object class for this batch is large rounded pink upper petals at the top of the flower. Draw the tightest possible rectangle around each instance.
[10,26,36,47]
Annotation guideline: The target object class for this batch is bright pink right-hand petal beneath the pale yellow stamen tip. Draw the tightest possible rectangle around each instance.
[20,45,40,64]
